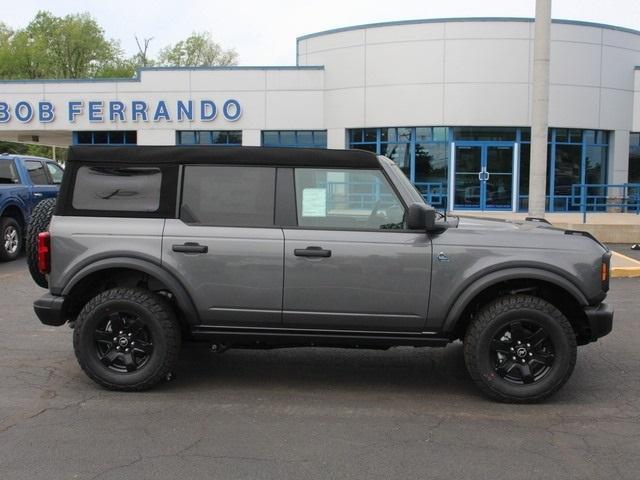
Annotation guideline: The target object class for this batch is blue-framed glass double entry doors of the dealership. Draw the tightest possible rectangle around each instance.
[453,142,513,210]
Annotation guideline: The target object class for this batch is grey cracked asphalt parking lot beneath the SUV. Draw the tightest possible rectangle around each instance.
[0,260,640,480]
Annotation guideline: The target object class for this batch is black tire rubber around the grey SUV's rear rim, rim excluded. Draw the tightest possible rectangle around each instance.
[73,288,180,391]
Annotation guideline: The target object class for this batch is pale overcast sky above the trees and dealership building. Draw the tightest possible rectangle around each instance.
[0,0,640,65]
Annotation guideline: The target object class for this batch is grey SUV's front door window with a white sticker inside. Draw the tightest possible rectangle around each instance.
[295,168,404,230]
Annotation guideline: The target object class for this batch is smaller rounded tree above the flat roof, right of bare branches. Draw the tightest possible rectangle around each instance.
[158,32,238,67]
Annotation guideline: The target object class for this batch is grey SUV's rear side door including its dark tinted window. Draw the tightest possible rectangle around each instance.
[162,165,284,326]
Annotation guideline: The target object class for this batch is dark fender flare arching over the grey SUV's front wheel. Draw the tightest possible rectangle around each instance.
[442,267,589,333]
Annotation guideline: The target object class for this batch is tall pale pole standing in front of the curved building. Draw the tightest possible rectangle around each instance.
[529,0,551,217]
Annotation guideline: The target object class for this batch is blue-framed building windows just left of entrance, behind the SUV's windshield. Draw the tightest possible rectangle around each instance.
[348,127,450,209]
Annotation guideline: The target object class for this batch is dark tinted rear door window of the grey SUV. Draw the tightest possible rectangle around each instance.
[180,165,276,227]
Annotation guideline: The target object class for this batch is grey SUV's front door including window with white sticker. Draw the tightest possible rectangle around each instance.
[283,168,431,332]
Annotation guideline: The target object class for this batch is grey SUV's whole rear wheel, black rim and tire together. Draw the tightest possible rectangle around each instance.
[73,288,180,391]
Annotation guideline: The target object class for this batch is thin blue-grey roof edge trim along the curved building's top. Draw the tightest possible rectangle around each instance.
[296,17,640,42]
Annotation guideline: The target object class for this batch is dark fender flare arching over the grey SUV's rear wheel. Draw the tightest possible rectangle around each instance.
[61,257,200,324]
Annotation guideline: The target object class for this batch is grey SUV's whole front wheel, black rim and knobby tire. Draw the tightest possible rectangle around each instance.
[464,295,577,403]
